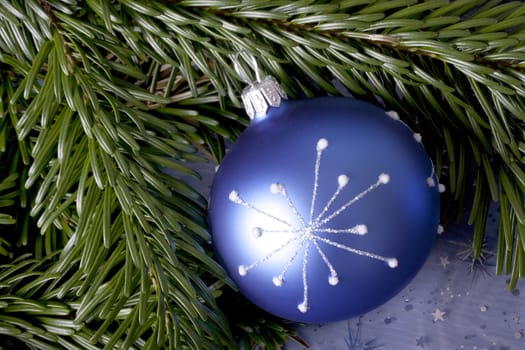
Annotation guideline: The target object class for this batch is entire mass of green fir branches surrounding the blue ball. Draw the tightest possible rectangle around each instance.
[0,0,525,349]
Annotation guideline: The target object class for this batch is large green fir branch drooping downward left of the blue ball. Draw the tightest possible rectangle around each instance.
[3,2,242,349]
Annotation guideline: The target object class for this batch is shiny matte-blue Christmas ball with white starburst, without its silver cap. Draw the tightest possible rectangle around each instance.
[209,97,440,323]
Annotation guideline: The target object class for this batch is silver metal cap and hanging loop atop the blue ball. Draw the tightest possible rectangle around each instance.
[233,51,288,120]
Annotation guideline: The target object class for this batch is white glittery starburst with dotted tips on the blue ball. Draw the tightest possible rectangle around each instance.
[229,138,398,313]
